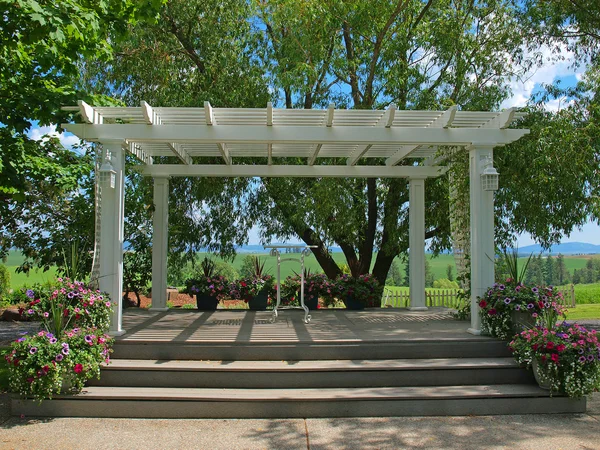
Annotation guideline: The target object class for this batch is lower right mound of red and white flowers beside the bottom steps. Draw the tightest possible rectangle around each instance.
[510,322,600,397]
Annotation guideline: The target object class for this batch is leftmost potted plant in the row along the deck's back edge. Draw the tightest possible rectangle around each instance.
[183,257,229,311]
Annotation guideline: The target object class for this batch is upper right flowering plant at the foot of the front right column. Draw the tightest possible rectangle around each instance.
[479,278,564,339]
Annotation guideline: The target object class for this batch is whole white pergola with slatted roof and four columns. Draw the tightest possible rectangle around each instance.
[63,101,529,335]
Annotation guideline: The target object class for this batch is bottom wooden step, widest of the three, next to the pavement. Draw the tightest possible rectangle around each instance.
[12,384,585,418]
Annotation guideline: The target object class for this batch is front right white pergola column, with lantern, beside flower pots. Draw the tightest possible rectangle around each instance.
[468,145,495,335]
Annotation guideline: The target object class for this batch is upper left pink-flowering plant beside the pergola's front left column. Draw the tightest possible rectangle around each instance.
[19,278,113,335]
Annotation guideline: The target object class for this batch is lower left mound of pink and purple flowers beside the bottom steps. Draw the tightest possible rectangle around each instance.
[5,328,112,401]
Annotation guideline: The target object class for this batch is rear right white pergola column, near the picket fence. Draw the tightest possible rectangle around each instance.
[408,178,427,311]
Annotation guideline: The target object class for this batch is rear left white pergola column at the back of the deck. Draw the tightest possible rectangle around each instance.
[150,177,169,311]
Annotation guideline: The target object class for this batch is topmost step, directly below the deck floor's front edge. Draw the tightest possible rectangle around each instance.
[113,336,511,361]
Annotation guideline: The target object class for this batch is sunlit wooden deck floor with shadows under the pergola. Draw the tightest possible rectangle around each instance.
[117,308,482,344]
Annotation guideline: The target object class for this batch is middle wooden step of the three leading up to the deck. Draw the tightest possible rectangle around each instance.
[90,358,533,388]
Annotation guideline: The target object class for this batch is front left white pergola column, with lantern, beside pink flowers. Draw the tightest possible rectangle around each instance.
[97,142,125,336]
